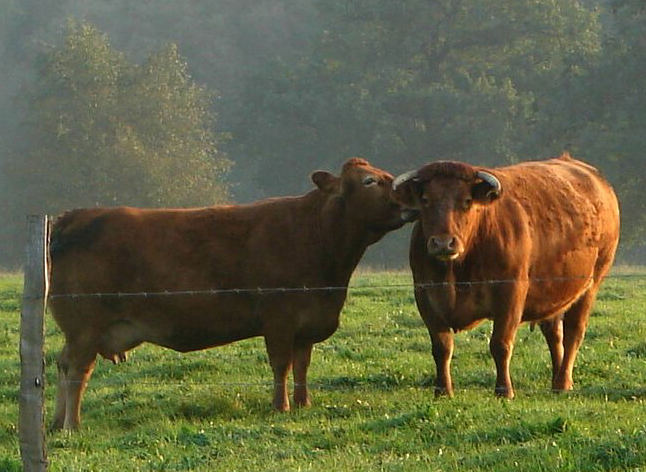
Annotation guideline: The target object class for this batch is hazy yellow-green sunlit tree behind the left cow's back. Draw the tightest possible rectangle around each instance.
[3,21,230,262]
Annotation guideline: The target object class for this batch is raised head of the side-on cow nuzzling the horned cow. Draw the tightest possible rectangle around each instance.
[312,157,418,237]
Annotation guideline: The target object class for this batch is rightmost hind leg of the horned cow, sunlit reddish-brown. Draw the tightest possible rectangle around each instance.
[552,286,599,392]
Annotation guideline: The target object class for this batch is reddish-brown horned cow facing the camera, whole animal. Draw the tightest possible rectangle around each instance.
[393,154,619,398]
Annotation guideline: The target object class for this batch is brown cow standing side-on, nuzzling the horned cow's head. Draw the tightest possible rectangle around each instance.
[50,158,415,429]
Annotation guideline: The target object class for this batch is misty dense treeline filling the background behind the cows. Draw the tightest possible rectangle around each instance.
[0,0,646,266]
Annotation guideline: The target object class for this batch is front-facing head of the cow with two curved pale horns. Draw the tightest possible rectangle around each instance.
[393,161,502,261]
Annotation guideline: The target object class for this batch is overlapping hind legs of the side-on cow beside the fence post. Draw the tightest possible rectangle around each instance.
[52,342,97,429]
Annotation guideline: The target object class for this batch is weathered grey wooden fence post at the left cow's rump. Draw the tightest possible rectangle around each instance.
[19,216,49,472]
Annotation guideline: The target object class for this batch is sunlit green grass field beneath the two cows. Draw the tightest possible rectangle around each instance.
[0,269,646,472]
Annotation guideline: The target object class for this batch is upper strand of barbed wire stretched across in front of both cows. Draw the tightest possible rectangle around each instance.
[41,274,646,300]
